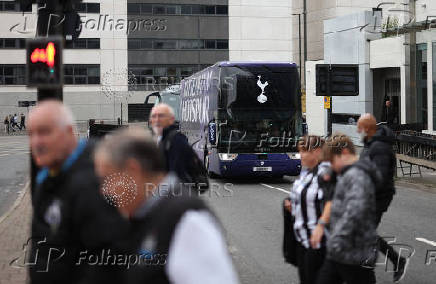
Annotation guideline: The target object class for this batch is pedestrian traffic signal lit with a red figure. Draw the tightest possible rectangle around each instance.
[26,37,64,88]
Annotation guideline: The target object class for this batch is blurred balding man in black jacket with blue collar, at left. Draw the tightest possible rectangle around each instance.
[27,101,127,284]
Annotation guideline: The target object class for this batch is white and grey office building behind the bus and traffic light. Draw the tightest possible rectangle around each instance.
[0,0,292,122]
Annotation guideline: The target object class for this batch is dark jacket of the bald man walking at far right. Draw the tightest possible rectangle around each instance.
[360,126,397,212]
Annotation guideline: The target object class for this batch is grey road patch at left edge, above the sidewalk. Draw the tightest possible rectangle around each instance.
[0,136,30,217]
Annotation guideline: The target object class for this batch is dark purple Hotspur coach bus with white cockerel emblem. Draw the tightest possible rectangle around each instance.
[179,62,303,177]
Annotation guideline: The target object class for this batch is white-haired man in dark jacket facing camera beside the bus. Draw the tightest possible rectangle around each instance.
[150,103,197,182]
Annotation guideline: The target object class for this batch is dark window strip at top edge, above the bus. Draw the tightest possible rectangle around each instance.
[127,3,228,15]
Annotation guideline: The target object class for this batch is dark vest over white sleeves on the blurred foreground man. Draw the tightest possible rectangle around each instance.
[123,177,214,284]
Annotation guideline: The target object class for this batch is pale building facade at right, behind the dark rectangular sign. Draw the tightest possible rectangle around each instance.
[306,1,436,143]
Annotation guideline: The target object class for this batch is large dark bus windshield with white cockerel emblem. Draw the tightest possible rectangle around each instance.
[218,65,302,153]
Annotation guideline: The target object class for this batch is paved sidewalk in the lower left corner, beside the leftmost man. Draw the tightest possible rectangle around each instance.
[0,186,31,284]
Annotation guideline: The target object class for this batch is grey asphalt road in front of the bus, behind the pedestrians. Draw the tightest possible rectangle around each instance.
[205,178,436,284]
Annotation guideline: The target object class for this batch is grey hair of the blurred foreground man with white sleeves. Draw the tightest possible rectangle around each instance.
[95,127,166,172]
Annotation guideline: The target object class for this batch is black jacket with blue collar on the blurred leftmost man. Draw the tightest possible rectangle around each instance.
[29,141,128,284]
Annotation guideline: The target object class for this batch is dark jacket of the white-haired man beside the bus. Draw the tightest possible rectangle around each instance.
[159,125,192,182]
